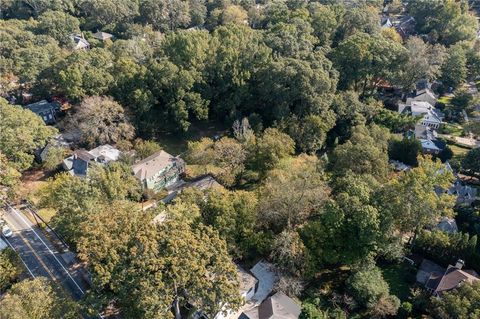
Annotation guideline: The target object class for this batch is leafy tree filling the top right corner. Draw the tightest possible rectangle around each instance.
[408,0,478,45]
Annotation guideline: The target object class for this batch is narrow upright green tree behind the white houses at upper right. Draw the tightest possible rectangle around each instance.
[441,45,468,88]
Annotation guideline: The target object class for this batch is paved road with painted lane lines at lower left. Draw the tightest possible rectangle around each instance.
[3,208,87,300]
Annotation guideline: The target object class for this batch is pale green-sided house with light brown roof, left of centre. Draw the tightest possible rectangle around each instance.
[132,150,185,192]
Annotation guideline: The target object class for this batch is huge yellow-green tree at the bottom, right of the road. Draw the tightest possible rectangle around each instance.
[79,202,241,318]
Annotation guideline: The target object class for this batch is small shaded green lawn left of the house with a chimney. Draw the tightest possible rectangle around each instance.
[381,263,415,301]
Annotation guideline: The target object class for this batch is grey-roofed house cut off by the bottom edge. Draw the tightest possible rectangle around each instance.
[239,291,302,319]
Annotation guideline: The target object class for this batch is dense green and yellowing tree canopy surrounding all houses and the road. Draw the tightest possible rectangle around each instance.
[0,0,480,319]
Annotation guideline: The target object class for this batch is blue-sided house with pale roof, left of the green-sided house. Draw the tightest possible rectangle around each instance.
[62,144,121,177]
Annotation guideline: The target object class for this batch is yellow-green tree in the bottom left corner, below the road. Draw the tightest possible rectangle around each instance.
[0,277,79,319]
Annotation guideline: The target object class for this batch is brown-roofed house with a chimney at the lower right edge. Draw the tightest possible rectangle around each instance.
[417,259,480,297]
